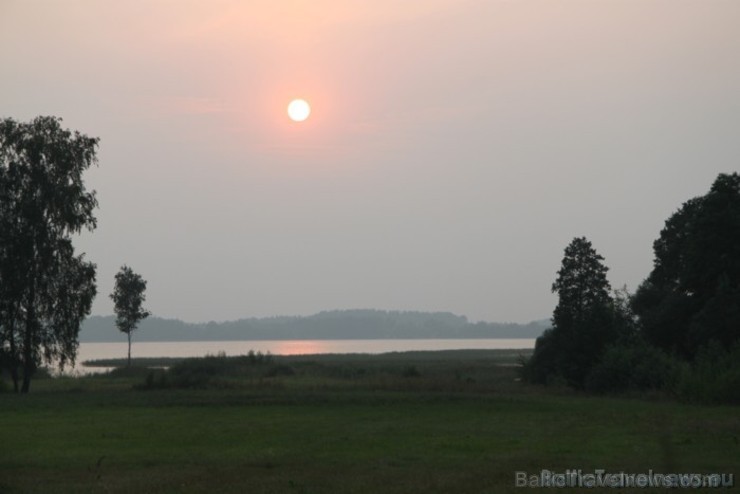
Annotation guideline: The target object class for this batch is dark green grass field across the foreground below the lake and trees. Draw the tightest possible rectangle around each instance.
[0,350,740,494]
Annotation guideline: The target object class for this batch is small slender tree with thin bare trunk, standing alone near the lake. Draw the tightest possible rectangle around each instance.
[110,265,149,367]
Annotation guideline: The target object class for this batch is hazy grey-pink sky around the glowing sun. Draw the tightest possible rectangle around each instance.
[0,0,740,322]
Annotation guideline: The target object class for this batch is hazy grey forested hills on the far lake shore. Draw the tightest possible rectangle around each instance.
[79,310,550,342]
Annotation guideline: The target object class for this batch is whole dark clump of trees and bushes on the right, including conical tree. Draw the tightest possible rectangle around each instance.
[523,173,740,403]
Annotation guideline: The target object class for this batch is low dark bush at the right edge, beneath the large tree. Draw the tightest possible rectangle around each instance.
[677,341,740,405]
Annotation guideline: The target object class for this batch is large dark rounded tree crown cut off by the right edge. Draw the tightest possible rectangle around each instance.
[632,173,740,358]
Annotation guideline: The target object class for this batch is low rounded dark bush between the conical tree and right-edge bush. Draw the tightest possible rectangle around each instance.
[585,340,684,393]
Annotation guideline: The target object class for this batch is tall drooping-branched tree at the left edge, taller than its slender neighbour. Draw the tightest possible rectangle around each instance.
[0,117,98,393]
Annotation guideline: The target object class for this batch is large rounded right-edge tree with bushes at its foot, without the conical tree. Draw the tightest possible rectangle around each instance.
[586,173,740,403]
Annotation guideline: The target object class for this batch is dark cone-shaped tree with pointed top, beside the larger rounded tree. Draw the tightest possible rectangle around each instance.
[526,237,623,388]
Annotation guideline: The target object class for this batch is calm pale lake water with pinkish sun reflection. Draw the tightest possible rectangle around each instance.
[68,338,535,372]
